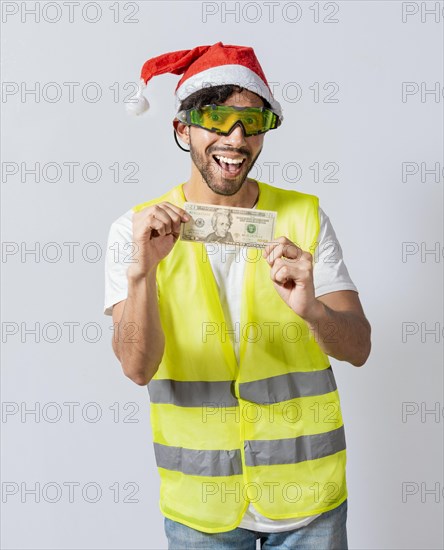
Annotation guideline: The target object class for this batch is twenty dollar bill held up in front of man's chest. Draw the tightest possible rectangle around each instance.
[180,202,277,248]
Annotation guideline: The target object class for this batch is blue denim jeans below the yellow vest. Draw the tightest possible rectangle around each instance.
[165,500,348,550]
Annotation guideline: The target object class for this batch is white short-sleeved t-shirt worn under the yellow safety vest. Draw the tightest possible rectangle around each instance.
[104,208,357,533]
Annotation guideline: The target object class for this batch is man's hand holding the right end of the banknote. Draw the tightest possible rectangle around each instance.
[263,237,323,321]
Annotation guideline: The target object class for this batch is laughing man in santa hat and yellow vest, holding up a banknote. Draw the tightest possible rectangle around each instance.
[105,42,370,550]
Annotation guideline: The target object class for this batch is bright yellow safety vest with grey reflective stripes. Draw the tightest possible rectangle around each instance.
[133,181,347,533]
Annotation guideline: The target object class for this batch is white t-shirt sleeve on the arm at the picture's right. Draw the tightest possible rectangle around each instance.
[313,207,358,298]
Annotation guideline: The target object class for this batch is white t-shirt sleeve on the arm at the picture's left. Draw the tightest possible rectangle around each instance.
[104,210,134,315]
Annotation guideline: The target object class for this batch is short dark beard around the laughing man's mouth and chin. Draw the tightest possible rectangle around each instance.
[189,136,262,196]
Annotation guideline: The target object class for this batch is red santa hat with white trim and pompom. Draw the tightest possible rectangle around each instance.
[126,42,283,121]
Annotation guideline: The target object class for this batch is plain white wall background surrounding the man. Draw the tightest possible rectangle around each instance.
[1,1,444,550]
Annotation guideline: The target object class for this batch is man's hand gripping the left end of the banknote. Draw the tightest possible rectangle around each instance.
[128,201,191,277]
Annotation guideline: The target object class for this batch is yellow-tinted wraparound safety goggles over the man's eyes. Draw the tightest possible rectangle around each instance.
[176,104,281,136]
